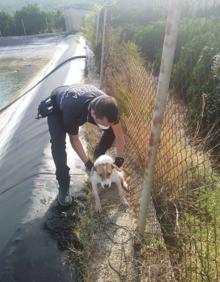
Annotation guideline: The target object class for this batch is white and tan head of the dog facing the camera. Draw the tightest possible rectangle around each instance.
[94,155,114,189]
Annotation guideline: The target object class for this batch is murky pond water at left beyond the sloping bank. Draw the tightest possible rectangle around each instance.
[0,35,63,109]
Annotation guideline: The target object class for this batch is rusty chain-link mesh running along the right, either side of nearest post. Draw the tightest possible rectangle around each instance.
[90,0,220,281]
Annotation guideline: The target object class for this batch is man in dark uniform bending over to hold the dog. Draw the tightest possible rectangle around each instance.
[42,84,124,206]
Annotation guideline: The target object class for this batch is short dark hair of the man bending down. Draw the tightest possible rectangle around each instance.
[94,96,119,123]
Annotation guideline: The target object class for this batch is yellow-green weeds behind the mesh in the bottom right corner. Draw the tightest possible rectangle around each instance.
[180,175,220,281]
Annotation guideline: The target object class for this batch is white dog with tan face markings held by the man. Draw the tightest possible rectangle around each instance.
[91,155,129,212]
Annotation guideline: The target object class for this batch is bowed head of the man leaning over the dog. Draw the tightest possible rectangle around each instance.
[92,96,119,127]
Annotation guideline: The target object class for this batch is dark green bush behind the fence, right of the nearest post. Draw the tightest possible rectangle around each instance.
[172,18,220,131]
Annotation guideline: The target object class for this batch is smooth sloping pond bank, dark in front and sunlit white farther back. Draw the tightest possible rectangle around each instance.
[0,33,85,282]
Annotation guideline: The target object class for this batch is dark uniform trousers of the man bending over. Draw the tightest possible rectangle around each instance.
[47,112,115,191]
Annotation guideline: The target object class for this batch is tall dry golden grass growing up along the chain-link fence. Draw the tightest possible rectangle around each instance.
[105,34,220,281]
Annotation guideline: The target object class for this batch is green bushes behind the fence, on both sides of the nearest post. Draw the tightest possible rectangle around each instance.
[113,6,220,139]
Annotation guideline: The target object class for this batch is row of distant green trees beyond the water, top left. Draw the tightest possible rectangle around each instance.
[0,5,65,36]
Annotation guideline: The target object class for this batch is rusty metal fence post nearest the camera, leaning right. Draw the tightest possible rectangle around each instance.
[138,0,181,235]
